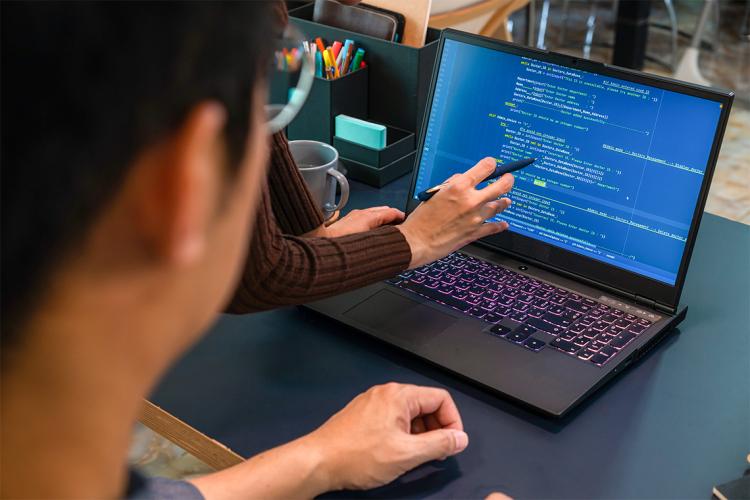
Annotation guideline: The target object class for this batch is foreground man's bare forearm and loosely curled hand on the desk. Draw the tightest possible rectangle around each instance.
[190,383,469,500]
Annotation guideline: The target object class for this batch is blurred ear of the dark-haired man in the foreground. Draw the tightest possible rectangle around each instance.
[136,102,226,266]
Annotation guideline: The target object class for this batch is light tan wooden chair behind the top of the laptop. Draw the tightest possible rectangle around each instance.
[429,0,529,42]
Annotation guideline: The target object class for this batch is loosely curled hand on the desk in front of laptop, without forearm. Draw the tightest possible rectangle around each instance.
[302,383,469,490]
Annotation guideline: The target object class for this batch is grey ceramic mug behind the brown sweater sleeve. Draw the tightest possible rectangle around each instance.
[289,141,349,219]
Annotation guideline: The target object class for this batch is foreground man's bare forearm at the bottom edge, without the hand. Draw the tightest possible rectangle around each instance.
[190,437,331,500]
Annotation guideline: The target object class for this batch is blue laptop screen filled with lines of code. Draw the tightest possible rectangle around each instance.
[414,39,721,285]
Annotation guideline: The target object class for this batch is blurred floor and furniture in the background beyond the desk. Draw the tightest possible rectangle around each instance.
[130,0,750,478]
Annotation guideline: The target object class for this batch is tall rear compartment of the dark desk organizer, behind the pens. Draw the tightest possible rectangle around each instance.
[289,4,440,132]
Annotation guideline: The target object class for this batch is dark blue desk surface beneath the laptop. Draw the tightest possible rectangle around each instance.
[152,178,750,498]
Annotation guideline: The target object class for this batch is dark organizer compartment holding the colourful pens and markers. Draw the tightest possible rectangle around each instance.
[287,68,369,144]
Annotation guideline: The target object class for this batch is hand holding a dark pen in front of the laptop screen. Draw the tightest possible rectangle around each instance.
[397,158,513,268]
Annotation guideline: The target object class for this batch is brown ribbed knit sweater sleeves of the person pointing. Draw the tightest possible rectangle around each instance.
[228,134,411,313]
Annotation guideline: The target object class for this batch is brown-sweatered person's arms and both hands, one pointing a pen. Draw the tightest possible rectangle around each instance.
[227,133,513,313]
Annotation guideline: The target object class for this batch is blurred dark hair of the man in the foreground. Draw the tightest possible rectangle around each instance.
[0,1,279,347]
